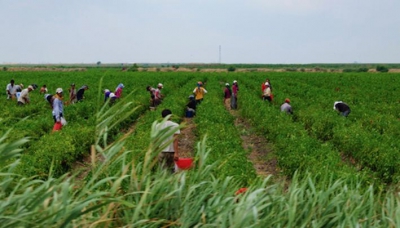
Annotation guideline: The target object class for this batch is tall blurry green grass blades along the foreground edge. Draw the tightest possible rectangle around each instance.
[0,99,400,227]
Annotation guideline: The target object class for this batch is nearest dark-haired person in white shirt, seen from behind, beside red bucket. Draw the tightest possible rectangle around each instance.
[156,109,181,173]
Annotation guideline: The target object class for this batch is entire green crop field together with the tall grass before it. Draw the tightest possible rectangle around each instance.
[0,68,400,227]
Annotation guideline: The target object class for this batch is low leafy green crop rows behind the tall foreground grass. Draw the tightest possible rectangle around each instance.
[0,71,400,183]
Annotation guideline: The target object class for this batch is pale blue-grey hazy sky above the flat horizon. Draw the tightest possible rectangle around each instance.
[0,0,400,64]
